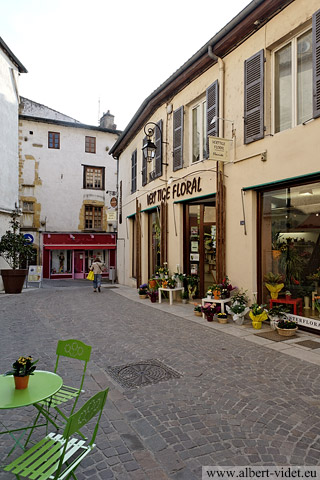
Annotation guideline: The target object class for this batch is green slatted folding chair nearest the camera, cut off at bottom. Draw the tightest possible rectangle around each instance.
[4,388,109,480]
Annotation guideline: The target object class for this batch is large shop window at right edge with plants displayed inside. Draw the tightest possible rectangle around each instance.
[260,183,320,318]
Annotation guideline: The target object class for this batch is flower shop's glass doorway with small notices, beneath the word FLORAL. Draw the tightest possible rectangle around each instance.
[184,197,217,298]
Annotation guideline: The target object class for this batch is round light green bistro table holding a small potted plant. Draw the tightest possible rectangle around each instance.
[0,370,63,456]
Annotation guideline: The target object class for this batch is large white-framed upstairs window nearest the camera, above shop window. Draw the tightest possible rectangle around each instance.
[273,28,313,133]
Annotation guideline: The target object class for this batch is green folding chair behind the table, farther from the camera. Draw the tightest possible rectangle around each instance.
[25,339,91,438]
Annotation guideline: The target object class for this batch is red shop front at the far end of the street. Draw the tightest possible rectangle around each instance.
[43,233,116,279]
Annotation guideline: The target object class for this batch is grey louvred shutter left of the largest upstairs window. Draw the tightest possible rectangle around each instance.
[244,50,264,143]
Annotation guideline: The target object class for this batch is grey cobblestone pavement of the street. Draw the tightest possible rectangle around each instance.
[0,282,320,480]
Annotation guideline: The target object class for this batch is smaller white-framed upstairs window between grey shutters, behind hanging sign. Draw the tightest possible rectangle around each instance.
[190,100,207,163]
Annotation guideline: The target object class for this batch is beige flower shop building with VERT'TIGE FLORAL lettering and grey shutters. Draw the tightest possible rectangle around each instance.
[111,0,320,329]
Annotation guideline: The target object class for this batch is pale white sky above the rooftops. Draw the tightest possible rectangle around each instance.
[0,0,250,130]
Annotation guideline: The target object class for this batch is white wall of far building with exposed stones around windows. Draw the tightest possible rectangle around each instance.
[19,117,117,240]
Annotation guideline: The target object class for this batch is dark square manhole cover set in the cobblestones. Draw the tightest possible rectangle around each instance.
[107,360,181,388]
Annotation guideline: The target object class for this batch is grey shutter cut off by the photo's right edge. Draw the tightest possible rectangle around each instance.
[312,10,320,118]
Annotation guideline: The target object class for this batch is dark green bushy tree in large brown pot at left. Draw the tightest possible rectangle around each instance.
[0,209,34,293]
